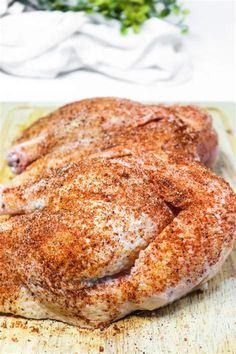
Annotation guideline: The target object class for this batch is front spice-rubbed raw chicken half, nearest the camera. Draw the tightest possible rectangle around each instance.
[0,146,236,328]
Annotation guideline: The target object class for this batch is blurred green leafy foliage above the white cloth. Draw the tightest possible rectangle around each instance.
[24,0,189,34]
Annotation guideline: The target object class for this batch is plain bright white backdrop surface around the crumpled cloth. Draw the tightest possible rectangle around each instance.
[0,0,236,102]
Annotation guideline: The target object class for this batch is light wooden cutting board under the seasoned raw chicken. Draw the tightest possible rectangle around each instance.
[0,103,236,354]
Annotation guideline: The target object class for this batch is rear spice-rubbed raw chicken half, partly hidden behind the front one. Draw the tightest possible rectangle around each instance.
[7,98,217,180]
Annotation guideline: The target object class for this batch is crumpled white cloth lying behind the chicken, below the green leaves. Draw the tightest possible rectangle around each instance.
[0,11,191,84]
